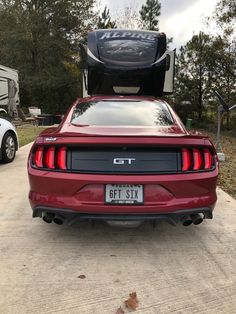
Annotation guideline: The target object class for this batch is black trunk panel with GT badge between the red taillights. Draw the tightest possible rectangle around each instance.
[69,147,181,174]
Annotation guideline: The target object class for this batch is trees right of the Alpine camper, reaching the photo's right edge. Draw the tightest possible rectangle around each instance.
[175,0,236,128]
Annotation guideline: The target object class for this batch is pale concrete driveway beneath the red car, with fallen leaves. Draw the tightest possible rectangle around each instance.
[0,145,236,314]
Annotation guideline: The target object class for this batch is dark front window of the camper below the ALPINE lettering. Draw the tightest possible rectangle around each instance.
[99,39,156,63]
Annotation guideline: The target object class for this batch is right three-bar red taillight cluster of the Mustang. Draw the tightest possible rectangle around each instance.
[181,148,214,171]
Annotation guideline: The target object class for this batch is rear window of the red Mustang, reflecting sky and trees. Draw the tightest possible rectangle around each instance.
[71,100,173,127]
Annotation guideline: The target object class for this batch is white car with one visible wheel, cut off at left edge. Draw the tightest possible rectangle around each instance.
[0,118,19,163]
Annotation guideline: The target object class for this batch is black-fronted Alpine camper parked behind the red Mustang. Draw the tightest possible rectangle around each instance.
[81,30,175,97]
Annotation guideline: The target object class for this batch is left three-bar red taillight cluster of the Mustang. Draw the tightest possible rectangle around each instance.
[32,146,67,170]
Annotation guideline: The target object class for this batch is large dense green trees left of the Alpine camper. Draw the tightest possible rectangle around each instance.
[0,0,94,112]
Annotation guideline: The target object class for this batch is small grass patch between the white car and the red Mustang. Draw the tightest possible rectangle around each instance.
[17,125,45,146]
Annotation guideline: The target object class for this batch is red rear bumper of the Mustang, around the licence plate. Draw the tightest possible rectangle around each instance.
[29,168,218,220]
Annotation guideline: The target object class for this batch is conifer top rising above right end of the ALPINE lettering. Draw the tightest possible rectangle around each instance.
[139,0,161,31]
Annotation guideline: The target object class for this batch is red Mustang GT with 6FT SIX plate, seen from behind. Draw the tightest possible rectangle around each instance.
[28,96,218,226]
